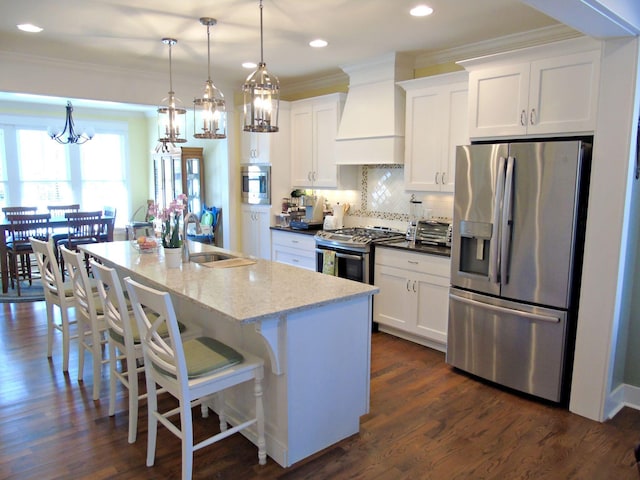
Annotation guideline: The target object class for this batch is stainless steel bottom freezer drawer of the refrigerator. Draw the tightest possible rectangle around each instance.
[446,288,567,402]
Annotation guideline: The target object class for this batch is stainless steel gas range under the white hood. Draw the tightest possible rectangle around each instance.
[315,227,404,284]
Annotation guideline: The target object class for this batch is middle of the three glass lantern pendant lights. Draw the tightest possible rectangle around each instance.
[193,17,227,139]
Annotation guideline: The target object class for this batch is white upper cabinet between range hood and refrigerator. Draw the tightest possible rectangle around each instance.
[399,72,469,192]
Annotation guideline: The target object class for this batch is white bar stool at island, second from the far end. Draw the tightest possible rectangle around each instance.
[60,245,109,400]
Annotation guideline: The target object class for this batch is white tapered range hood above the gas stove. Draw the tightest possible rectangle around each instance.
[335,53,413,165]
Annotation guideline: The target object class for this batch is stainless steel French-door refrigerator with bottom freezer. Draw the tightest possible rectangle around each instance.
[446,140,591,402]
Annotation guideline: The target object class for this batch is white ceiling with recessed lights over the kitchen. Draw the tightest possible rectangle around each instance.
[0,0,558,90]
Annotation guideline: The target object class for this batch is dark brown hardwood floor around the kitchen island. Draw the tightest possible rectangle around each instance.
[0,302,640,480]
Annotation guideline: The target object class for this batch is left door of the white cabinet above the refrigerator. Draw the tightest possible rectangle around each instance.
[469,63,529,137]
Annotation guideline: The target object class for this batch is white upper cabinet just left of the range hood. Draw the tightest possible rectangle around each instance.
[291,93,345,188]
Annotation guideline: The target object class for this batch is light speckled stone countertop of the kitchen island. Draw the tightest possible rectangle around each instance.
[80,241,379,323]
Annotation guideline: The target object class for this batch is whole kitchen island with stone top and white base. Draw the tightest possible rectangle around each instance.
[80,241,378,467]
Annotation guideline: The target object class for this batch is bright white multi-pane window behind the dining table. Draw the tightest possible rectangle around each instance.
[0,117,130,226]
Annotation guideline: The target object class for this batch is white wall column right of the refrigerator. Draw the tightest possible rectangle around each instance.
[569,38,638,421]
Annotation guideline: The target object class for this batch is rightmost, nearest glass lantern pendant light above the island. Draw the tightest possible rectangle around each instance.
[242,0,280,133]
